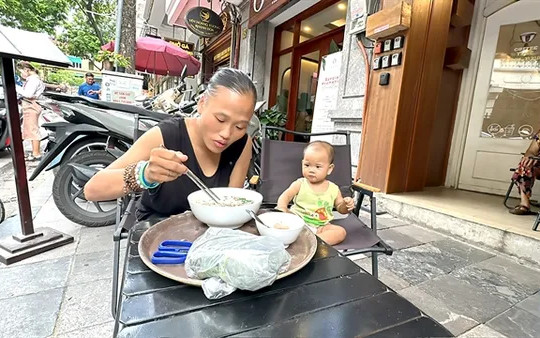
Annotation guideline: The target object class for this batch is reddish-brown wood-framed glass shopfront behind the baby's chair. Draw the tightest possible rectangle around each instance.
[269,0,347,137]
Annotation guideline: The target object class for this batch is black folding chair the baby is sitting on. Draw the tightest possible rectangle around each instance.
[251,127,393,277]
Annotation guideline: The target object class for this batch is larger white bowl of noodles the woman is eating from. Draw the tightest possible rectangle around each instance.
[188,188,263,229]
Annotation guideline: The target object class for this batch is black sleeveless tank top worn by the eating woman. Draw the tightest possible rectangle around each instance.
[137,118,247,220]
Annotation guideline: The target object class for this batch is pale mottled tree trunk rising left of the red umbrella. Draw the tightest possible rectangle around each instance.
[120,0,137,74]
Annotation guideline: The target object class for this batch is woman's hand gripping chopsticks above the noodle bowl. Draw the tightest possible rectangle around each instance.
[144,147,187,184]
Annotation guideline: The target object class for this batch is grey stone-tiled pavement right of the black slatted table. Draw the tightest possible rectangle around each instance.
[356,215,540,337]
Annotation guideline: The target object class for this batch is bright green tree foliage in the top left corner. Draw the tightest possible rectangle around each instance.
[0,0,71,35]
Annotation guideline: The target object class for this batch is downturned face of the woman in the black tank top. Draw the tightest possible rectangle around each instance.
[198,87,255,153]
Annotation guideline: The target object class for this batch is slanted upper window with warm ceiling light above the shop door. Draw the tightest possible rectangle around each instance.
[300,1,347,42]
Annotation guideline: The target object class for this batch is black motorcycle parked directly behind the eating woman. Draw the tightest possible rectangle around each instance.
[30,68,196,227]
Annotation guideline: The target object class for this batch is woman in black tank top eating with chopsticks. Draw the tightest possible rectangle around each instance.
[84,68,257,220]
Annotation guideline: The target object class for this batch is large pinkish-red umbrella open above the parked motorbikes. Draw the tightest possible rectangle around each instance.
[101,37,201,76]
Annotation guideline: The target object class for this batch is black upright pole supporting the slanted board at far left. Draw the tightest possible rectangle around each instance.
[2,57,34,236]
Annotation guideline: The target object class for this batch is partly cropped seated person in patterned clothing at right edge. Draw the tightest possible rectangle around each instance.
[510,131,540,215]
